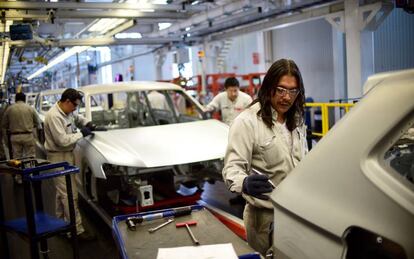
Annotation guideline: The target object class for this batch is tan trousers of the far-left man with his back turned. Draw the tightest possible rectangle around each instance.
[10,134,36,158]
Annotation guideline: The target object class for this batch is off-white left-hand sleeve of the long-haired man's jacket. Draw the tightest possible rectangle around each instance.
[222,117,254,193]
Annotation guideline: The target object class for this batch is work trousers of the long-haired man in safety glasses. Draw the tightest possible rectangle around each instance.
[243,203,273,256]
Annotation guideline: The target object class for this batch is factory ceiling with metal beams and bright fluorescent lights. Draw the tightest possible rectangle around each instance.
[0,0,343,85]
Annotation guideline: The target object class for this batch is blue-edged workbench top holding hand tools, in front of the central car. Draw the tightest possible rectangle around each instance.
[112,205,259,259]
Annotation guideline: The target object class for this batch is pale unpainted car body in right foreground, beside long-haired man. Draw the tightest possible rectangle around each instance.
[271,70,414,259]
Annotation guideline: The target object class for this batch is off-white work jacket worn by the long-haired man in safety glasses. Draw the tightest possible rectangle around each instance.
[222,103,308,209]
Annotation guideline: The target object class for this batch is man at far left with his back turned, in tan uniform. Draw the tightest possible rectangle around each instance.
[2,93,41,183]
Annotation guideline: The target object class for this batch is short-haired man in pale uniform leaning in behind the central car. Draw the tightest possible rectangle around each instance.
[206,77,252,125]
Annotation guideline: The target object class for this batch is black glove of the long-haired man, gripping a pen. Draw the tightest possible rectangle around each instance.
[242,174,273,200]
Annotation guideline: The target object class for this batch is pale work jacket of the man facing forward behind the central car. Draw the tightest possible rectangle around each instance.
[206,91,253,125]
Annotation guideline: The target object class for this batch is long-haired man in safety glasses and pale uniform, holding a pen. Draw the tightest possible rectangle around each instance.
[223,59,308,256]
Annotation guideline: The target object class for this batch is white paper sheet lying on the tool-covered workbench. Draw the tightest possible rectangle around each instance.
[157,243,238,259]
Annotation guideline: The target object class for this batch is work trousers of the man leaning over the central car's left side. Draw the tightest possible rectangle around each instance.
[47,151,85,235]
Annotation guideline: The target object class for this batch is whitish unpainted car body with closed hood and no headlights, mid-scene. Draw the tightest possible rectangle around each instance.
[56,82,228,217]
